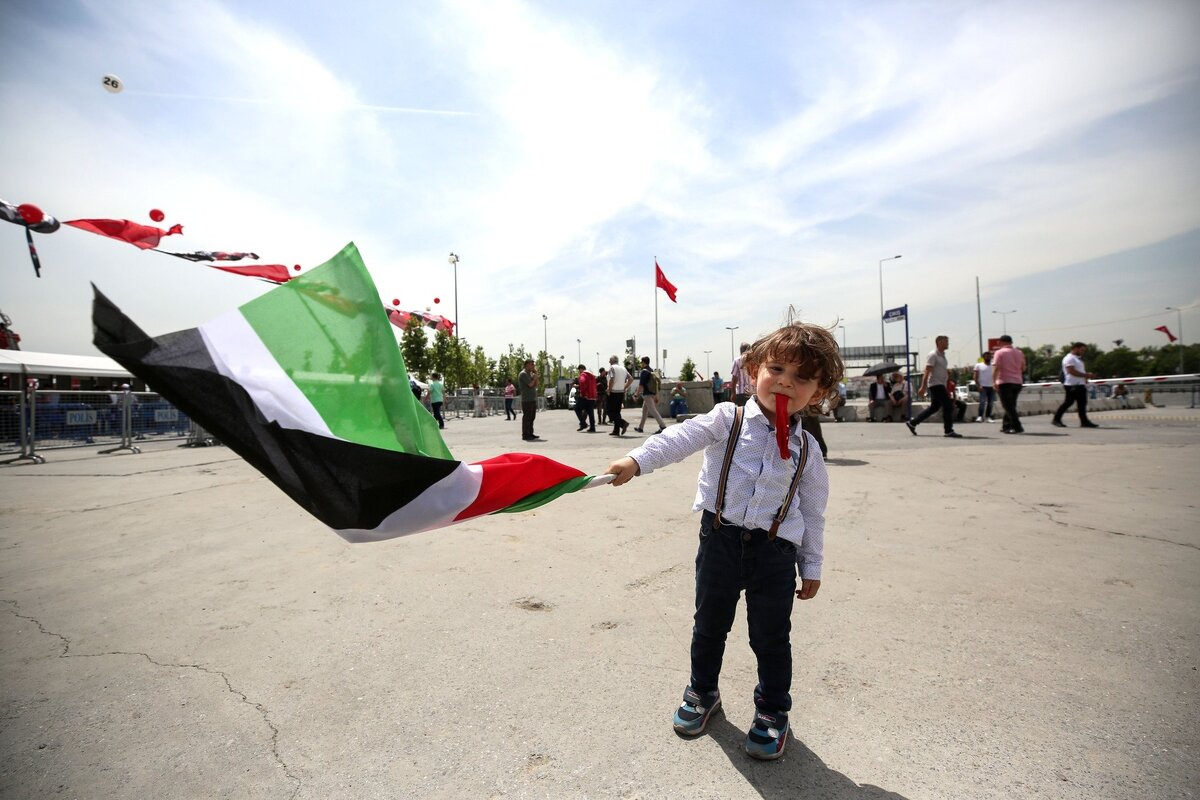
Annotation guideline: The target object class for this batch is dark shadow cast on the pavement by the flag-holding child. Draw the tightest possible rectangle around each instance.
[708,714,906,800]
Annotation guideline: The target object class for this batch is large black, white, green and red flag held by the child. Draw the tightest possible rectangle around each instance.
[92,245,602,542]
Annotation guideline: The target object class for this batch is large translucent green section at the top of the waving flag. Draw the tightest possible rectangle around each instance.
[239,242,454,459]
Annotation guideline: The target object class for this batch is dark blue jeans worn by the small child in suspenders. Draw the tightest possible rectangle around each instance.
[691,511,796,714]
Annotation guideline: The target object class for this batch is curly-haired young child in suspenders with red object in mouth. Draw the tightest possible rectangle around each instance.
[607,323,842,759]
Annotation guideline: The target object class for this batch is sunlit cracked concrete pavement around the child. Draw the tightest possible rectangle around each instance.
[0,408,1200,800]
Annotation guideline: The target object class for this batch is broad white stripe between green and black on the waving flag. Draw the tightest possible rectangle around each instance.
[197,311,341,439]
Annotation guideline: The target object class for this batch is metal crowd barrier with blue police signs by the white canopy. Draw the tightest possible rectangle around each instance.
[0,390,199,463]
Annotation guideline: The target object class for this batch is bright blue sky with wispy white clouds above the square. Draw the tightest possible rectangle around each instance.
[0,0,1200,375]
